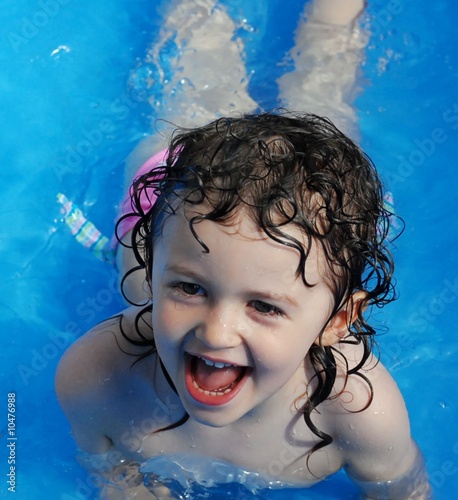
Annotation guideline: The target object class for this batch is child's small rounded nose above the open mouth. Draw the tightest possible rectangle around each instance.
[196,307,244,350]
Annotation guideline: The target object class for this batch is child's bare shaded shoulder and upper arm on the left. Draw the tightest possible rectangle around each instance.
[55,309,155,453]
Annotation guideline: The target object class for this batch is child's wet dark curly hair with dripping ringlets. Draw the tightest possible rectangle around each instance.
[118,112,395,462]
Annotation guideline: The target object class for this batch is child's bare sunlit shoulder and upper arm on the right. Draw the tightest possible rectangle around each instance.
[327,345,418,482]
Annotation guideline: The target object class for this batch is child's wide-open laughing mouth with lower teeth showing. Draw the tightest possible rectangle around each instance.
[185,354,252,406]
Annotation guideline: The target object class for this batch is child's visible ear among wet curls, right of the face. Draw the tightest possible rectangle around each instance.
[315,292,367,347]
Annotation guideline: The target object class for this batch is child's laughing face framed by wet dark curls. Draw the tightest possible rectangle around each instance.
[152,205,334,427]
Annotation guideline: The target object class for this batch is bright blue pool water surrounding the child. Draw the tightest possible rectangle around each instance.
[0,0,458,500]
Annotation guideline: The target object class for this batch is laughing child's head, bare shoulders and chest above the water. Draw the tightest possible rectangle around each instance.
[57,114,430,499]
